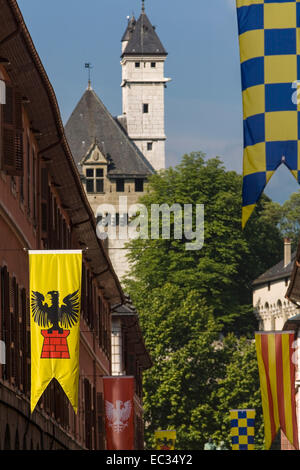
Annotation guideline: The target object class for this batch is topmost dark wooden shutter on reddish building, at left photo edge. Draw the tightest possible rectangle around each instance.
[1,84,23,176]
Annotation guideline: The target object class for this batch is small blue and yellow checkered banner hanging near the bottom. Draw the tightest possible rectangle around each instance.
[230,410,255,450]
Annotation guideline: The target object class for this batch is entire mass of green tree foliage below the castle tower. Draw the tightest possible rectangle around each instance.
[126,152,282,449]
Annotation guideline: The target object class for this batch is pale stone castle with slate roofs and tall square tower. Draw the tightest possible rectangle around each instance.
[65,5,169,280]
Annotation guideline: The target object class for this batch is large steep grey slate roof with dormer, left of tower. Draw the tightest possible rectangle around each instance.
[65,89,154,178]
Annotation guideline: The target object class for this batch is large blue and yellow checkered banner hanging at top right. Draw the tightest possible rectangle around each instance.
[236,0,300,227]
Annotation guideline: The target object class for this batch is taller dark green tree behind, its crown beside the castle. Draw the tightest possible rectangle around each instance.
[127,152,282,334]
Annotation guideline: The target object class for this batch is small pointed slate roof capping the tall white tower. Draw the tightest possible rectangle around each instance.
[122,12,167,57]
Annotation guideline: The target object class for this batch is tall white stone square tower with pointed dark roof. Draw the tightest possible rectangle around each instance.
[121,1,170,170]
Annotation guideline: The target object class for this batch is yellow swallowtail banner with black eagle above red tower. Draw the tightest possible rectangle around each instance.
[29,250,82,413]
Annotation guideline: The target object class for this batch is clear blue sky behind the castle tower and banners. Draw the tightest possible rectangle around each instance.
[18,0,299,203]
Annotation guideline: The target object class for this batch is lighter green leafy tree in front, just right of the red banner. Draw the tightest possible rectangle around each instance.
[141,284,222,450]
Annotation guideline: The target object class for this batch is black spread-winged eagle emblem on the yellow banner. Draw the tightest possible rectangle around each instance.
[31,290,80,334]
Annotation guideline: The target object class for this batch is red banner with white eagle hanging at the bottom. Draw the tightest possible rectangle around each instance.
[103,376,134,450]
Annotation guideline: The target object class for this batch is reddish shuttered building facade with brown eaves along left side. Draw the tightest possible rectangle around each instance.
[0,0,151,450]
